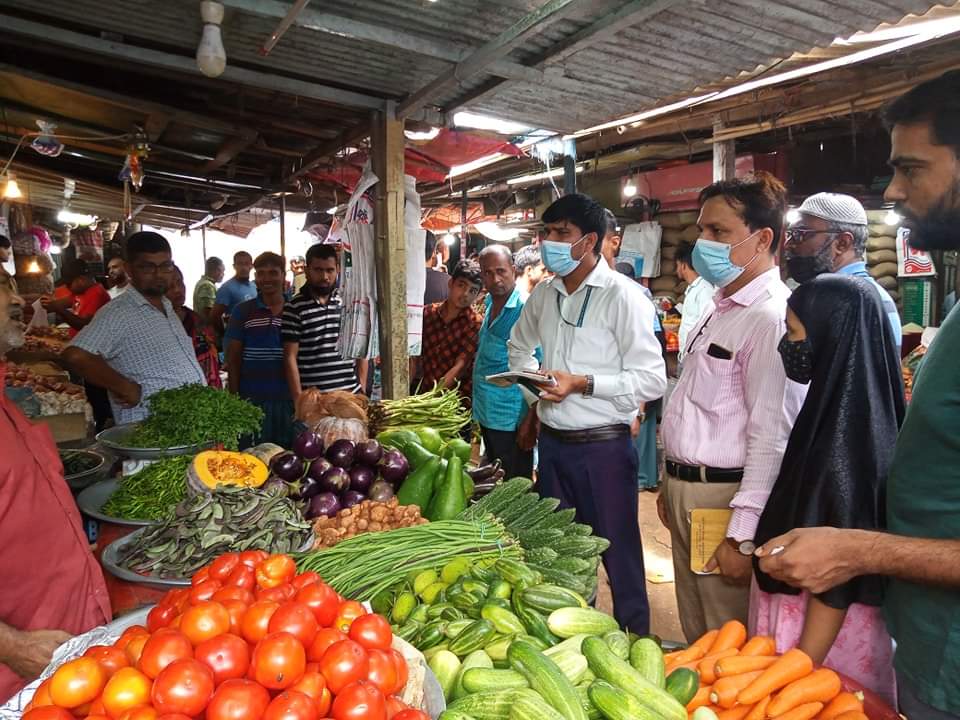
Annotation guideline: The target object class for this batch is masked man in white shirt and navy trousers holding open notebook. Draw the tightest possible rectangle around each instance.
[508,194,667,635]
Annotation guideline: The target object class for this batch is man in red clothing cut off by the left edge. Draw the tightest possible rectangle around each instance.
[0,283,111,704]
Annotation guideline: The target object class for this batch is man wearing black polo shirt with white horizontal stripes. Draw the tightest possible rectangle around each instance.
[283,245,366,403]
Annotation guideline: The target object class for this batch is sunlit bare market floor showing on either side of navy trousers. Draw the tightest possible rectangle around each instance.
[597,492,683,642]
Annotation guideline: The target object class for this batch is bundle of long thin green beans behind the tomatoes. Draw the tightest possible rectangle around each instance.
[295,517,521,600]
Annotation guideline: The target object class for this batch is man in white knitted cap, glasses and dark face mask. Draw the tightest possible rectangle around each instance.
[783,193,903,350]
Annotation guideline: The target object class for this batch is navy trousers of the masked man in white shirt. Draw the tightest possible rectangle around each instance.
[537,433,650,635]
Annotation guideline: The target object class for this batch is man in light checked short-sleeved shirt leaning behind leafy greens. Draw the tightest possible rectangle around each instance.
[63,232,206,425]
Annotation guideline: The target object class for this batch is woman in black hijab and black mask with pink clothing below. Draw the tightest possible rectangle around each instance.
[750,274,904,697]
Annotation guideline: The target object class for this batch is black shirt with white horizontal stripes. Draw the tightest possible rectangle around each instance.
[283,287,360,392]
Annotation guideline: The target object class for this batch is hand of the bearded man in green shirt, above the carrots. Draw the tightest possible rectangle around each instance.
[756,527,871,594]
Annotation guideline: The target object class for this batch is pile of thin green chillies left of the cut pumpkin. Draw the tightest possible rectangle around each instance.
[103,455,192,520]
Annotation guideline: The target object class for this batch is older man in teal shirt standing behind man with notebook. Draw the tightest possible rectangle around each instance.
[473,245,534,477]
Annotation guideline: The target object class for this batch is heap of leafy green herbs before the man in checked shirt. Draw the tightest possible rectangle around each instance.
[128,385,263,450]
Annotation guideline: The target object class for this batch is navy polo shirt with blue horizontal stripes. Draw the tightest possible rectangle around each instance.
[224,295,289,400]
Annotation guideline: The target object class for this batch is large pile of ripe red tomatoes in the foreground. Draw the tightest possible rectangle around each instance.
[23,551,429,720]
